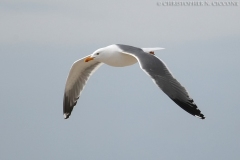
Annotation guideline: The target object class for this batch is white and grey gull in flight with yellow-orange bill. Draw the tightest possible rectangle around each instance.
[63,44,205,119]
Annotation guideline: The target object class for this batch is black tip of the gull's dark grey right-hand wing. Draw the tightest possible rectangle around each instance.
[172,99,205,119]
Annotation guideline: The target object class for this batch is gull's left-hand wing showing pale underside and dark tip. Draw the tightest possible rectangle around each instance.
[63,57,102,119]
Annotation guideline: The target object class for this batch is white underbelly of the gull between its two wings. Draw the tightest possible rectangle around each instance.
[103,53,137,67]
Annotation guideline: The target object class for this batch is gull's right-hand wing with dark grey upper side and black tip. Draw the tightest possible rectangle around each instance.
[119,45,205,119]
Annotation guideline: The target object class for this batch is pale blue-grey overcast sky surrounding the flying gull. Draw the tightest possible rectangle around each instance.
[0,0,240,160]
